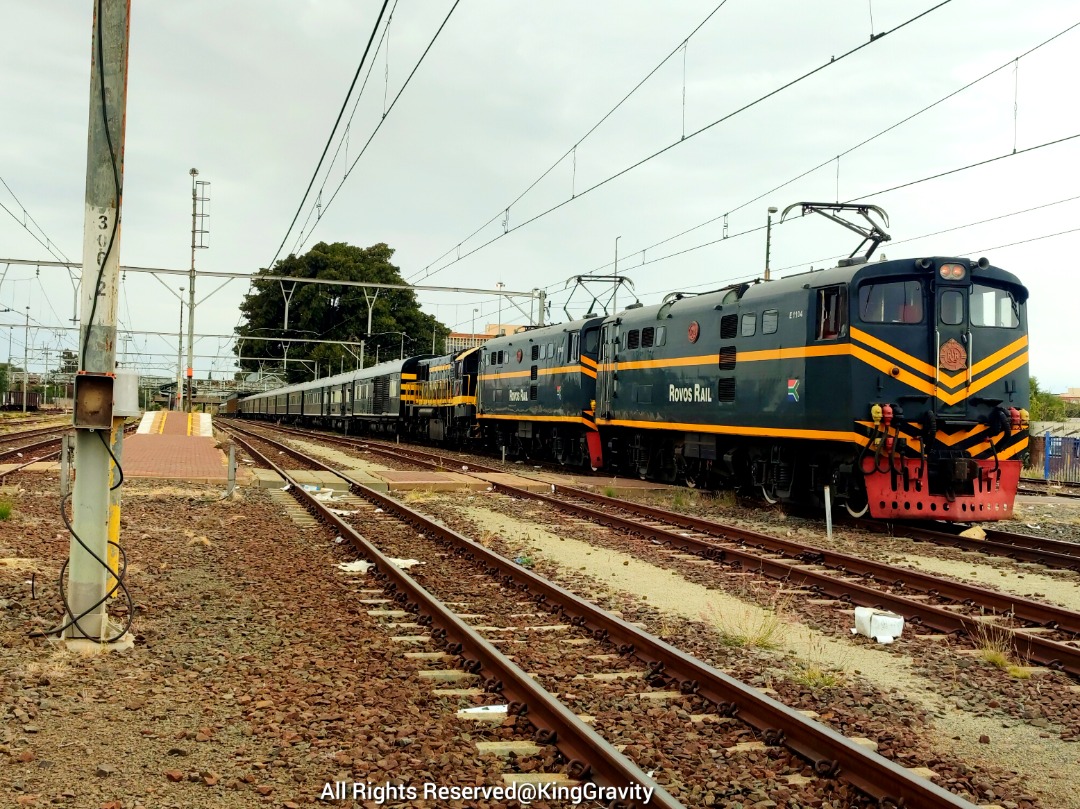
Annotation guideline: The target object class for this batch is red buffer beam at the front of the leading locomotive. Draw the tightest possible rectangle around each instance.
[863,458,1022,523]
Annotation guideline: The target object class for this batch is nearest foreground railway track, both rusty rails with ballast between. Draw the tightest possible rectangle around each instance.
[227,424,970,807]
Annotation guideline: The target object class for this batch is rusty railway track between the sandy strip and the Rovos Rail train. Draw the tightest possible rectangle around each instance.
[236,423,1080,676]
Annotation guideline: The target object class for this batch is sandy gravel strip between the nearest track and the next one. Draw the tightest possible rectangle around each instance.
[411,486,1080,807]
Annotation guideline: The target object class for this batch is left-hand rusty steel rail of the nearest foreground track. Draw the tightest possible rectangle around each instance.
[224,426,683,809]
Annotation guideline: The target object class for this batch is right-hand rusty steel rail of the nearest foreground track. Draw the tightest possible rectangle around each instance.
[223,419,972,809]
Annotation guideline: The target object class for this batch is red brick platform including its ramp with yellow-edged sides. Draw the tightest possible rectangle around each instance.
[121,410,229,483]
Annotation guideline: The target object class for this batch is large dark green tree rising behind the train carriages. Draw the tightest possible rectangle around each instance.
[233,242,449,382]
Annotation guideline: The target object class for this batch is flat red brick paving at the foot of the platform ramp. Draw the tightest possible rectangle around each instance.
[121,436,229,483]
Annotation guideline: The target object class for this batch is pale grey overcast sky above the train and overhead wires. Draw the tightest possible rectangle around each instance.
[0,0,1080,391]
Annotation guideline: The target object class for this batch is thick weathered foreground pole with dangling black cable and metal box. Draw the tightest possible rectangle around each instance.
[65,0,131,645]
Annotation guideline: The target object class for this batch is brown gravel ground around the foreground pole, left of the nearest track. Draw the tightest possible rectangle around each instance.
[0,475,548,809]
